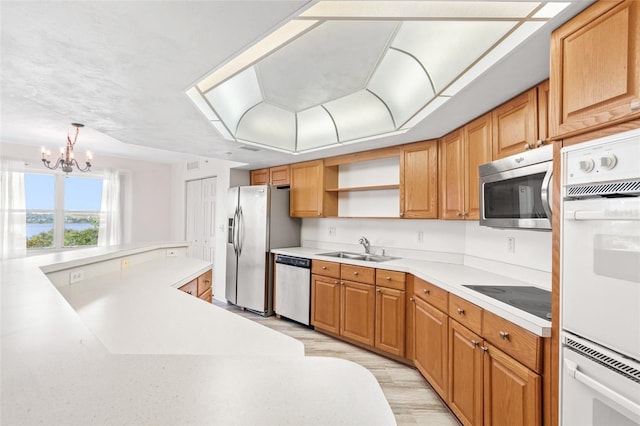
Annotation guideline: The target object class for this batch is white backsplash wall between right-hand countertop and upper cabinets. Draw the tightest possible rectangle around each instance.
[301,219,551,289]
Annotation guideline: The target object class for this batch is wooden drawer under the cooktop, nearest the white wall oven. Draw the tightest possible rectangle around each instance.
[482,311,542,373]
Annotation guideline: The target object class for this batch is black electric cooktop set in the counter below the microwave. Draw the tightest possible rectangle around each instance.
[463,285,551,321]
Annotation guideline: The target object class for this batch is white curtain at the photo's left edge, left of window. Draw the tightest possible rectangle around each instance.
[0,160,27,259]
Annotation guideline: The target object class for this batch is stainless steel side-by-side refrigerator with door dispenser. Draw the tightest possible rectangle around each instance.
[226,185,300,316]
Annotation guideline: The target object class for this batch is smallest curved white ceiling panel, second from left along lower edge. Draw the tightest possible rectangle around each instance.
[296,106,338,151]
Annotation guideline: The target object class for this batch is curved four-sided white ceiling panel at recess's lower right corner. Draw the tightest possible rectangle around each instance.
[367,49,434,127]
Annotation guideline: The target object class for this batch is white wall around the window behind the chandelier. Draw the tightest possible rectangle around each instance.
[0,143,172,242]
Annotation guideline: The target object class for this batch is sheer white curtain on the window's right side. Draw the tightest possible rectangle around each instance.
[98,169,122,246]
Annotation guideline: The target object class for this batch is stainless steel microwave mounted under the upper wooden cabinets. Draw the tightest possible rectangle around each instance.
[479,145,553,230]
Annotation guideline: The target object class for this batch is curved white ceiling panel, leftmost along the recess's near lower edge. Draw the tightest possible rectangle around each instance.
[236,103,296,151]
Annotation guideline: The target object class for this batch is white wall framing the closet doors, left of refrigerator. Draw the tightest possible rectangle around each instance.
[170,158,249,300]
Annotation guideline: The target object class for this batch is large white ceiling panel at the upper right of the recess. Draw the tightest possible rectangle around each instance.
[392,21,517,92]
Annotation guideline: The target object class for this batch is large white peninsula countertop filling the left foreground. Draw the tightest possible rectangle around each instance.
[0,244,395,425]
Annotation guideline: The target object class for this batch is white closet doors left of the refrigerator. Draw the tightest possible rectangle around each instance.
[185,177,216,263]
